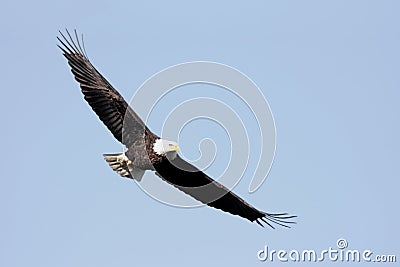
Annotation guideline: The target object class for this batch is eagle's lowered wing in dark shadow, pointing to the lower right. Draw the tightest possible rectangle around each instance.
[154,156,297,228]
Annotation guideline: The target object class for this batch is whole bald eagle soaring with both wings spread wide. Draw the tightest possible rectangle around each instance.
[57,30,296,228]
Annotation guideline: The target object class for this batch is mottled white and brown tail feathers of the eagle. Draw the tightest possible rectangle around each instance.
[103,153,145,181]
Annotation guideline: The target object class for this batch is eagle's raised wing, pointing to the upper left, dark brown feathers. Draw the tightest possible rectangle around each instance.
[57,30,150,148]
